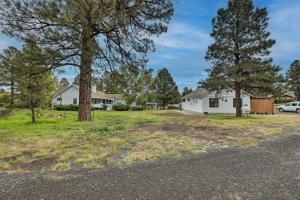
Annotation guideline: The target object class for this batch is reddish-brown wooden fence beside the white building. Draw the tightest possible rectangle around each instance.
[251,98,274,114]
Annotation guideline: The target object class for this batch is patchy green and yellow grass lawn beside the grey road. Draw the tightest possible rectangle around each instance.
[0,110,300,172]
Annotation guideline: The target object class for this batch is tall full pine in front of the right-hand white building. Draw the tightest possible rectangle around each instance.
[202,0,280,116]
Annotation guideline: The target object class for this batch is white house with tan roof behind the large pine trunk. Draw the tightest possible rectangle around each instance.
[52,85,126,110]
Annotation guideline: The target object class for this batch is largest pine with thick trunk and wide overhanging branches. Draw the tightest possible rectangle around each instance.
[0,0,173,121]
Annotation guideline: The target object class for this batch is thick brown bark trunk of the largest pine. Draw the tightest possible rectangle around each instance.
[78,31,93,121]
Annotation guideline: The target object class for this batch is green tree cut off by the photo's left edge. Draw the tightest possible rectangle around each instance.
[0,47,21,109]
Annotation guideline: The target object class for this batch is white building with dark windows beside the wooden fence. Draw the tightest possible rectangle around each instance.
[182,89,251,114]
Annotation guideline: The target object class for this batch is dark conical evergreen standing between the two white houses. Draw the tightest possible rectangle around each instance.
[154,68,181,109]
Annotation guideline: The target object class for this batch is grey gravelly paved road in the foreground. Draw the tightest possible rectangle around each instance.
[0,135,300,200]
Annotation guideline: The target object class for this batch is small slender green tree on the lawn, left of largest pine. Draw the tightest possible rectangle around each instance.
[18,43,55,123]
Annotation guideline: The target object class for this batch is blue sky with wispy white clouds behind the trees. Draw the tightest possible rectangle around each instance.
[0,0,300,89]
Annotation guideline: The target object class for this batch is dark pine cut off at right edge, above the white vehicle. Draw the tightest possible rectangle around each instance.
[287,60,300,101]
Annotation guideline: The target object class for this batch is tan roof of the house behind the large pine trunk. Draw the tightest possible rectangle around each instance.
[53,85,124,100]
